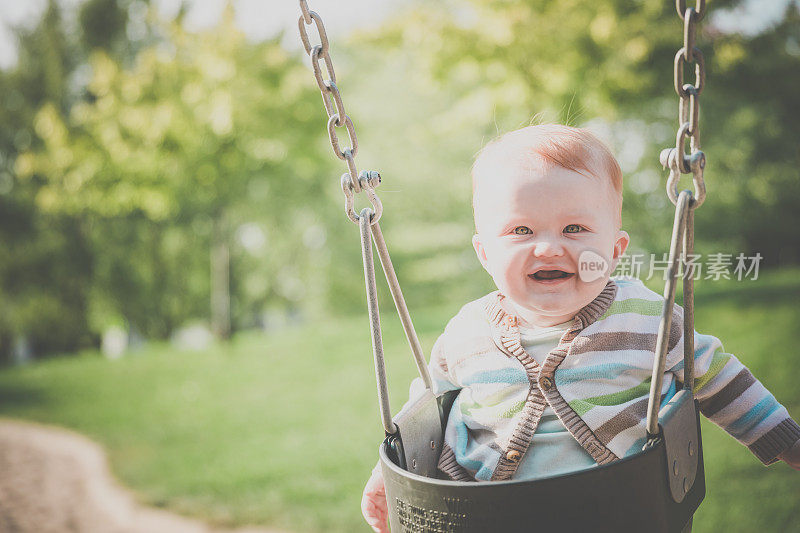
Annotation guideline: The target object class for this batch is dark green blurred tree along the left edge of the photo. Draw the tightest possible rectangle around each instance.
[0,1,92,360]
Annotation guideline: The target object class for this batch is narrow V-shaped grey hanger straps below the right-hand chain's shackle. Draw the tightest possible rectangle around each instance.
[647,190,694,437]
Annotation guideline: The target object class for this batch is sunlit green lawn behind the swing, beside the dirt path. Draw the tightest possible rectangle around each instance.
[0,270,800,533]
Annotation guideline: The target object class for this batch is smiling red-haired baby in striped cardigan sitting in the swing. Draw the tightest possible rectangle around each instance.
[362,125,800,532]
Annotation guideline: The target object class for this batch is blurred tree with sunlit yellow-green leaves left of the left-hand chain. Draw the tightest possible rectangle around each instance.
[16,6,329,337]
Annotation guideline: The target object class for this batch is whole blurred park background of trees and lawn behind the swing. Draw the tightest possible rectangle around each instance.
[0,0,800,532]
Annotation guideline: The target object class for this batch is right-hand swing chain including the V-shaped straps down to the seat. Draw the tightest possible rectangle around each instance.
[647,0,706,438]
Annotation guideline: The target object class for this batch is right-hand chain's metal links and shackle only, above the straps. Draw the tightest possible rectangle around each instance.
[661,0,706,209]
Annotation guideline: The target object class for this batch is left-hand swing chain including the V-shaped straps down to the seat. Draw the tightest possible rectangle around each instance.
[298,0,433,434]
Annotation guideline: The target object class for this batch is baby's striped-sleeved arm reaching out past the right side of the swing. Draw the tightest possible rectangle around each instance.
[669,332,800,469]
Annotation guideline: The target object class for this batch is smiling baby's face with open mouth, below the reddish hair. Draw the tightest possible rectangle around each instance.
[473,161,629,326]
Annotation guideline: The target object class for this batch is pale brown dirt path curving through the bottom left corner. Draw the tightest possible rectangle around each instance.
[0,420,286,533]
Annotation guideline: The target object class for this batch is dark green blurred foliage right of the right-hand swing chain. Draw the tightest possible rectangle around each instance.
[698,8,800,264]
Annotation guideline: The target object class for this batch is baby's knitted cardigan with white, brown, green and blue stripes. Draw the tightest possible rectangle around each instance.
[422,280,800,481]
